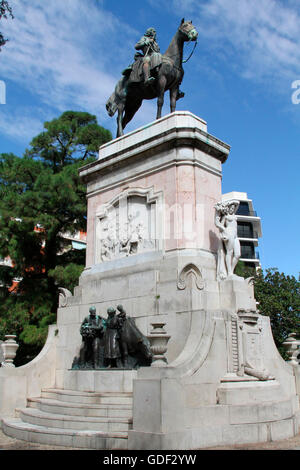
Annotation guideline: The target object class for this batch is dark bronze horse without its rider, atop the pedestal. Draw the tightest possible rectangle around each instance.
[106,19,198,137]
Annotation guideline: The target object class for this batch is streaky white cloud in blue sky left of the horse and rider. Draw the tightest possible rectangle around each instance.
[0,0,149,138]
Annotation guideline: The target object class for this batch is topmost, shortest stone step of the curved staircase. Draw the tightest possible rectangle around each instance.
[41,388,132,405]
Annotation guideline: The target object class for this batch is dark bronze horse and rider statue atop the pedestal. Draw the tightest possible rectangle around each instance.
[106,19,198,137]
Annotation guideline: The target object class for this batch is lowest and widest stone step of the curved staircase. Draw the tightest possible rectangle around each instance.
[2,418,127,450]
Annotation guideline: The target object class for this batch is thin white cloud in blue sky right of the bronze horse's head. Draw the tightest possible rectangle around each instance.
[166,0,300,86]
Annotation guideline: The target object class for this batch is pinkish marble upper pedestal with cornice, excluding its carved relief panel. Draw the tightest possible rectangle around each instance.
[80,111,229,267]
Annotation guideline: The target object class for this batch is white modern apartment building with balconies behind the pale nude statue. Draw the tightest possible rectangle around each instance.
[222,191,262,268]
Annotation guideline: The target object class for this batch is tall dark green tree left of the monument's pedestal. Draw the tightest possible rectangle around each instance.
[0,111,111,363]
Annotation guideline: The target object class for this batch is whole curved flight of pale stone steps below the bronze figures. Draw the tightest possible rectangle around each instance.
[2,389,132,449]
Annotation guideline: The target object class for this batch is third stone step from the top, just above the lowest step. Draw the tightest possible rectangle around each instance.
[17,408,132,437]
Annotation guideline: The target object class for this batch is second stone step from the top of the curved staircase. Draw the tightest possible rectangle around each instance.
[27,398,132,418]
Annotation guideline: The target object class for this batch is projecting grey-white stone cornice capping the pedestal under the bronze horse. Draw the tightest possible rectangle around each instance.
[79,111,230,183]
